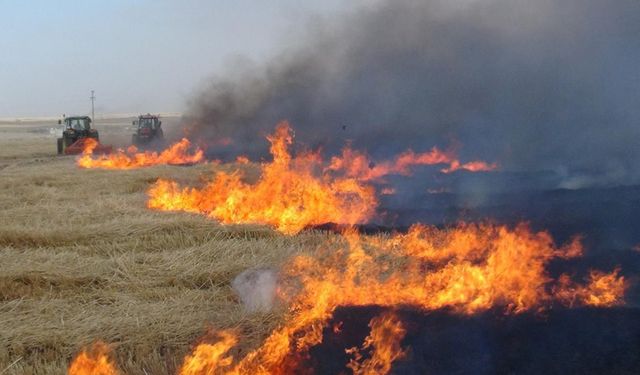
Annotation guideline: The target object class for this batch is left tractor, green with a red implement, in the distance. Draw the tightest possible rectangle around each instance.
[58,116,111,155]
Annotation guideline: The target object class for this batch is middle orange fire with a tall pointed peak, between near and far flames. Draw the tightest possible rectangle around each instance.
[147,122,377,234]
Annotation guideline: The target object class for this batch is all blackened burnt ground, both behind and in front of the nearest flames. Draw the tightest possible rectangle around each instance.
[308,173,640,375]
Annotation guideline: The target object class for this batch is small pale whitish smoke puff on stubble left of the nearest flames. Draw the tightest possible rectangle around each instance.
[231,268,277,312]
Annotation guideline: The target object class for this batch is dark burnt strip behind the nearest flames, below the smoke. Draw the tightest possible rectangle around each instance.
[378,172,640,249]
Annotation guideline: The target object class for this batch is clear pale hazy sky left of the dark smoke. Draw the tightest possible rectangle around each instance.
[0,0,352,117]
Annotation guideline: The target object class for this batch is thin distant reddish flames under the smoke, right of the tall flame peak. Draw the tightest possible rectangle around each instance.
[326,147,498,181]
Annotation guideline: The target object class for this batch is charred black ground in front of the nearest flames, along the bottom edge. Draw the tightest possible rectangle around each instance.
[307,306,640,375]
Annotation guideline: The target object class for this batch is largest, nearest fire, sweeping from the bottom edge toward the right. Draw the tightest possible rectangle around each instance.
[175,224,626,374]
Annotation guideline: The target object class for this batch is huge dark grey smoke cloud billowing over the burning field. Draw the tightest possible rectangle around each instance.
[185,0,640,187]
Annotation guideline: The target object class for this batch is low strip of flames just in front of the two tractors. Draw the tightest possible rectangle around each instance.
[77,138,204,169]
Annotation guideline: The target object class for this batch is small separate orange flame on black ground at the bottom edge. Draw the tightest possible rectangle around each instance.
[346,313,406,375]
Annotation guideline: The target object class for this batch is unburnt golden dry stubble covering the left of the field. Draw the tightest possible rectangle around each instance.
[0,122,326,375]
